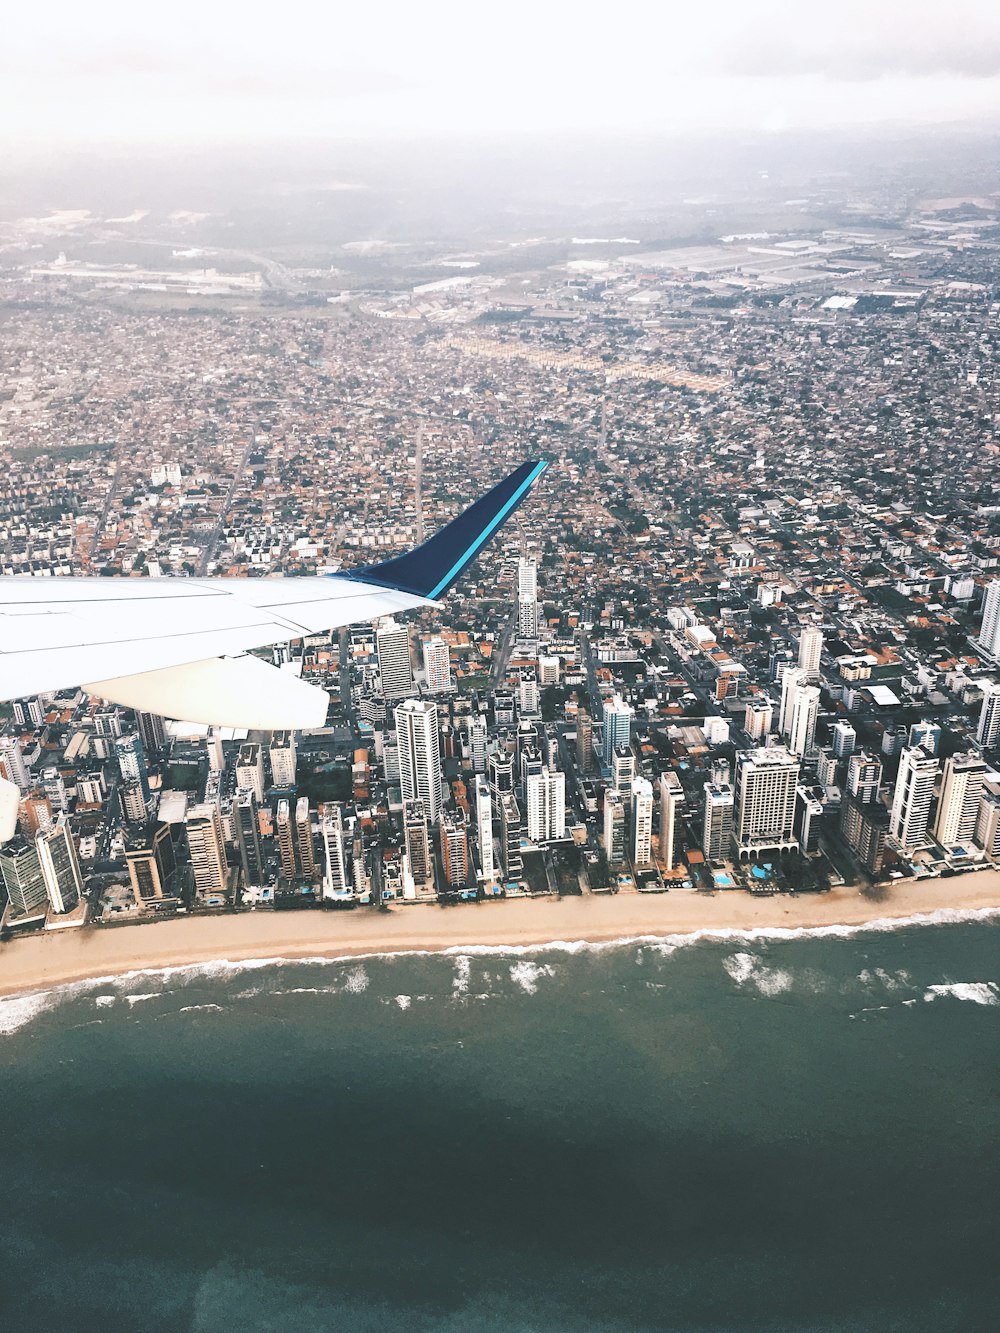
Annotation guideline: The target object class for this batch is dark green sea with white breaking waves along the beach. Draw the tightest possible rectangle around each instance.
[0,921,1000,1333]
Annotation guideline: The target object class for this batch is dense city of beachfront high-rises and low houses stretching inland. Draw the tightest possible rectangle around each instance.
[0,182,1000,936]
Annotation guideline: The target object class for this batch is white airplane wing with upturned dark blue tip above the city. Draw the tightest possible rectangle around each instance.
[0,463,545,730]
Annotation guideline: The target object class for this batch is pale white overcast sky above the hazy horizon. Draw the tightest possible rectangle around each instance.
[0,0,1000,145]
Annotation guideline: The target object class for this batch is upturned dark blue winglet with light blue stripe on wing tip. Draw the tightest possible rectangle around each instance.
[341,460,548,600]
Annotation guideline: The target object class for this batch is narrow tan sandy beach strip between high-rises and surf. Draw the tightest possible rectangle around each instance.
[0,870,1000,997]
